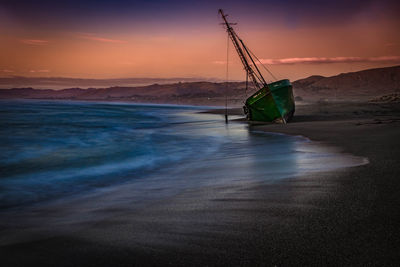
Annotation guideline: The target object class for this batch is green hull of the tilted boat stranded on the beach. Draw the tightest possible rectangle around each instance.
[244,80,295,123]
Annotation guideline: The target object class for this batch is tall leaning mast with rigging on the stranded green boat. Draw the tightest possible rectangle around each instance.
[218,9,268,90]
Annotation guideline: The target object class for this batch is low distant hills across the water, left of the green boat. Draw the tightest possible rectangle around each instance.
[0,82,245,105]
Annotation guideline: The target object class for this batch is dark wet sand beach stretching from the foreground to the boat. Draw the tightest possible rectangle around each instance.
[0,100,400,266]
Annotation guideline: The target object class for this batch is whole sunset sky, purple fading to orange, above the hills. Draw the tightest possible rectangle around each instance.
[0,0,400,81]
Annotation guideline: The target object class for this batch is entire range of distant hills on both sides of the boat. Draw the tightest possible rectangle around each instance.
[0,66,400,105]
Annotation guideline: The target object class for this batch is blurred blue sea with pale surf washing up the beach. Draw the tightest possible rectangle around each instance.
[0,100,365,210]
